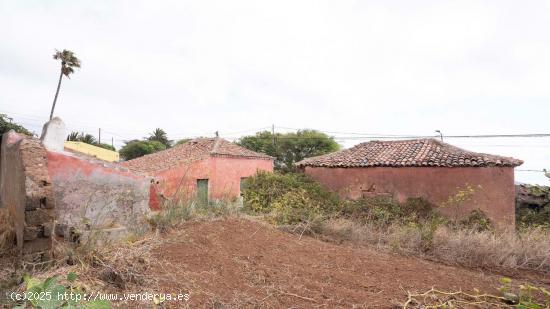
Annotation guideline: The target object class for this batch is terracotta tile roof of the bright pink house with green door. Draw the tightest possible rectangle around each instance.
[121,138,273,174]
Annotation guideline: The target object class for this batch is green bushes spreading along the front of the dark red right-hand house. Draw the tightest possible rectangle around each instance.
[243,172,446,226]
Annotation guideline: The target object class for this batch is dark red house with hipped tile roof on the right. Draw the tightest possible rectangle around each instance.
[297,139,523,226]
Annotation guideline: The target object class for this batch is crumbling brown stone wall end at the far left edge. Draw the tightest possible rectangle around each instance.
[0,131,55,264]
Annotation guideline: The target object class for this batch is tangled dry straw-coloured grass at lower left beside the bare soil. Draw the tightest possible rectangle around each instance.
[0,233,183,308]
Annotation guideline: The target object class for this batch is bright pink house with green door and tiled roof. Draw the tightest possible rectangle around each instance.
[122,138,274,208]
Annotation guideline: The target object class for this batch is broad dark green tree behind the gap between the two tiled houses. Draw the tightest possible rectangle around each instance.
[237,130,340,171]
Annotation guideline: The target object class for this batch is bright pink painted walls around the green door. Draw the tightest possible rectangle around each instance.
[154,156,273,199]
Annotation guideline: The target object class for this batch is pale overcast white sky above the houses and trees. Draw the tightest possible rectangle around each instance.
[0,0,550,184]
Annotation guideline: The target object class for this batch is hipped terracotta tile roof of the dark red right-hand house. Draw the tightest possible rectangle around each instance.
[296,139,523,167]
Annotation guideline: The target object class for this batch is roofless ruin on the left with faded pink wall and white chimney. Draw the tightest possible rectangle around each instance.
[0,118,151,265]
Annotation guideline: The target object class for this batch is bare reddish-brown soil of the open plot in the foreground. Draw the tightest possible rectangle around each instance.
[154,219,528,308]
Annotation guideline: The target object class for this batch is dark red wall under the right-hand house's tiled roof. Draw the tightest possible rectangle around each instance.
[305,167,515,227]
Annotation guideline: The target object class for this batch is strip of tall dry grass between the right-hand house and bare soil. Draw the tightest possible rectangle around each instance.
[316,219,550,273]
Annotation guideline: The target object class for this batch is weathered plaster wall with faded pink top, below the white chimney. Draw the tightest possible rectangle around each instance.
[47,151,150,236]
